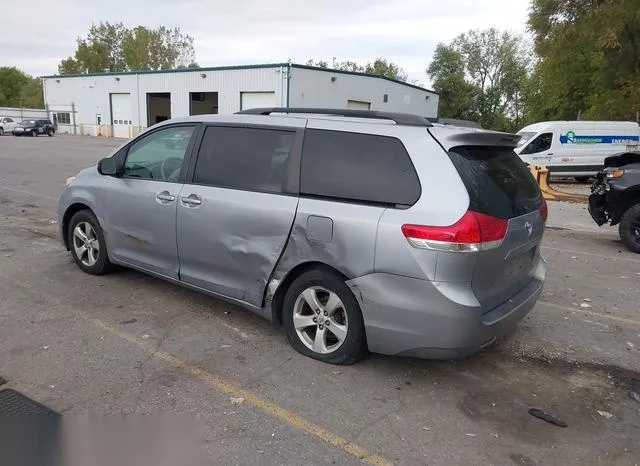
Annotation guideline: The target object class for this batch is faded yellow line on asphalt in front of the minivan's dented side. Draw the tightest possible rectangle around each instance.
[85,316,391,465]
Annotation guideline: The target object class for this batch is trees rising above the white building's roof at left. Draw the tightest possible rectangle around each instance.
[58,22,197,74]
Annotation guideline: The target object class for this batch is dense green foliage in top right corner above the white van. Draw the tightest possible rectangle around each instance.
[527,0,640,120]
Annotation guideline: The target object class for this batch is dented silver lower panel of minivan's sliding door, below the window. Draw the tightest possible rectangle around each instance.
[178,185,298,307]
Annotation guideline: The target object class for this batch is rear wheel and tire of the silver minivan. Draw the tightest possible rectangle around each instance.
[282,269,368,365]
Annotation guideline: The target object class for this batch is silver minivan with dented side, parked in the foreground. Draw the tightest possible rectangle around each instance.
[59,109,547,364]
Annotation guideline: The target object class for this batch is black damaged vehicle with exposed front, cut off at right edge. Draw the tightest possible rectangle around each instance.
[589,152,640,253]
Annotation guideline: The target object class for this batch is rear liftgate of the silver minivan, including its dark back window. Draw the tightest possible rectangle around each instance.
[449,146,544,310]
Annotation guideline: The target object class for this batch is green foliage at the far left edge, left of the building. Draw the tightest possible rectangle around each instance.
[0,66,44,108]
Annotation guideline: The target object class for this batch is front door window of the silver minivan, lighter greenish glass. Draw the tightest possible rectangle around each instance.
[123,126,193,181]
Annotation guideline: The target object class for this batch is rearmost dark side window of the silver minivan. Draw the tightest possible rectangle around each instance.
[300,129,421,206]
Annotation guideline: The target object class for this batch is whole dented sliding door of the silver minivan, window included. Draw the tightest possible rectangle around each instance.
[177,126,303,306]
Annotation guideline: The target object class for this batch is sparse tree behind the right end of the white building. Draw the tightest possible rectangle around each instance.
[427,28,530,131]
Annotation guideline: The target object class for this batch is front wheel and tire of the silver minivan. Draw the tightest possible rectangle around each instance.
[68,210,113,275]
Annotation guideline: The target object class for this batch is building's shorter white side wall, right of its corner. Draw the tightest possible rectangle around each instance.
[289,65,438,117]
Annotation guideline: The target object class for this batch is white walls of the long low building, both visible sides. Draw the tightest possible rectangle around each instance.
[43,65,438,137]
